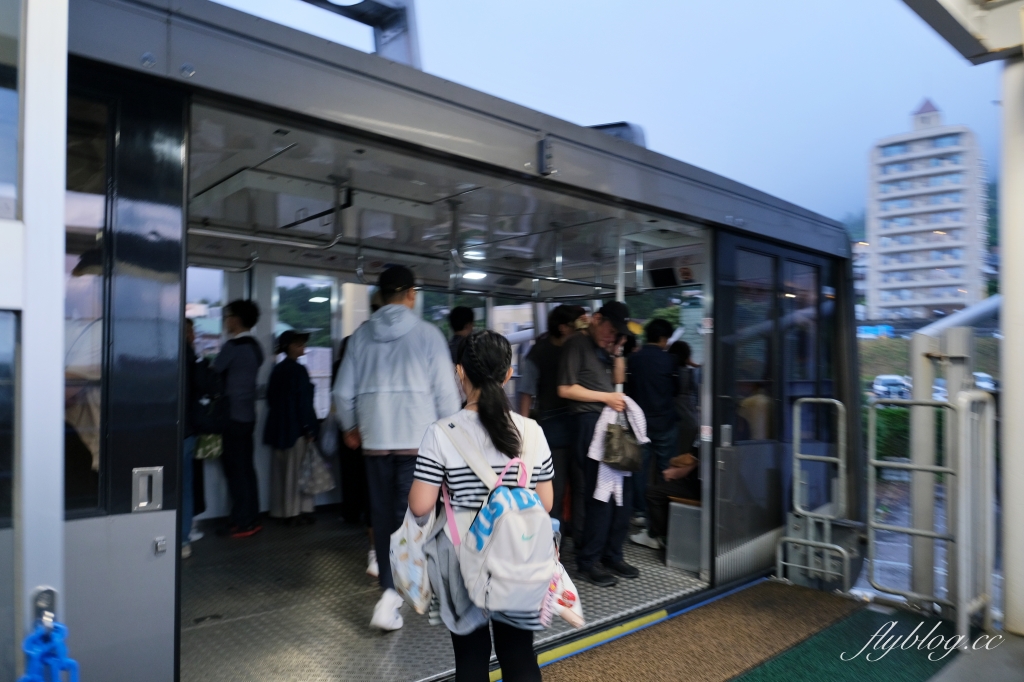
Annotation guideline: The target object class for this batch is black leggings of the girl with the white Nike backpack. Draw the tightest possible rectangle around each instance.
[452,621,541,682]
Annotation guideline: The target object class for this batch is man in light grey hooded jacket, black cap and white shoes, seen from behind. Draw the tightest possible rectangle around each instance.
[334,265,462,630]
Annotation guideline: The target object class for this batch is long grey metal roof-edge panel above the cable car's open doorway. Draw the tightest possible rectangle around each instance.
[66,0,849,257]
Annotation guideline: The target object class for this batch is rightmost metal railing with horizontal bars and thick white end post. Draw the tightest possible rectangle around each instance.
[867,390,995,637]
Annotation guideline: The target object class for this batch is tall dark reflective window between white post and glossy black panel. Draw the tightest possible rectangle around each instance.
[65,97,110,510]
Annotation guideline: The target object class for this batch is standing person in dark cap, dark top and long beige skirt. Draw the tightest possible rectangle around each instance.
[263,330,318,525]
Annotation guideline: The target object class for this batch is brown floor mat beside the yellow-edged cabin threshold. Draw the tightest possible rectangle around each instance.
[544,582,860,682]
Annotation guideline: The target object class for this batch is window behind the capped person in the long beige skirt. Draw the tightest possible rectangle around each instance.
[273,276,334,419]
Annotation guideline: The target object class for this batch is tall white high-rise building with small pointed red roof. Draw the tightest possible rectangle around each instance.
[866,99,988,319]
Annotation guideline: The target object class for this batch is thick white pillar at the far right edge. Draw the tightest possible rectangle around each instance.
[999,58,1024,635]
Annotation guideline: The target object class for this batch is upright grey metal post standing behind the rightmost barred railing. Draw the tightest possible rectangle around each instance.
[913,334,939,595]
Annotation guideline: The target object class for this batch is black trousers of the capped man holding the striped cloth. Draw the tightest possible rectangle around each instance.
[577,412,633,570]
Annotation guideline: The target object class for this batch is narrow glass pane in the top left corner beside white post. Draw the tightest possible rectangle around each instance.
[0,0,22,219]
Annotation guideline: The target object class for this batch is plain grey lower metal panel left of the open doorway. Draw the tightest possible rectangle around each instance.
[63,511,177,682]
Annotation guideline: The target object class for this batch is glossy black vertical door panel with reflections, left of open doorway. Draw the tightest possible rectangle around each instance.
[105,67,185,514]
